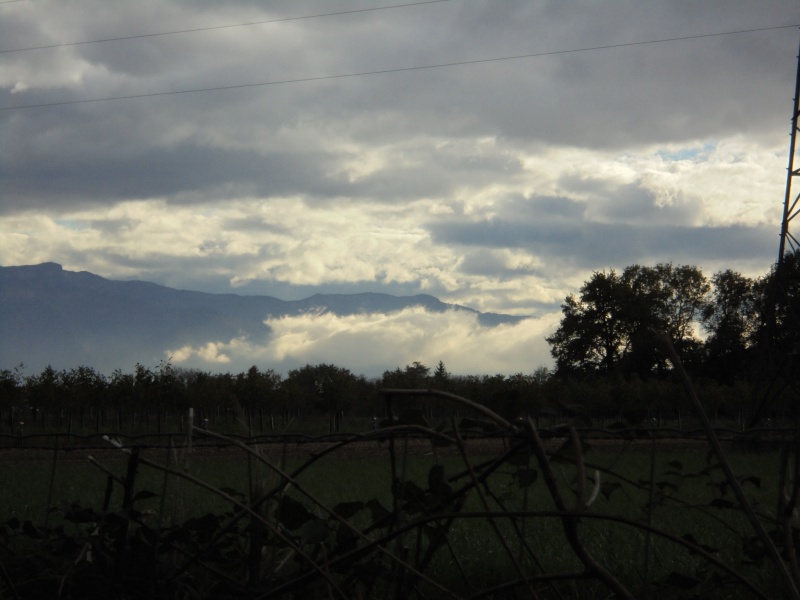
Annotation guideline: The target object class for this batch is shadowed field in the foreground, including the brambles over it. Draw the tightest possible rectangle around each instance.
[0,414,794,598]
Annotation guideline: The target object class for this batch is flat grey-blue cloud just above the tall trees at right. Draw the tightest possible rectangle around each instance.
[428,186,777,274]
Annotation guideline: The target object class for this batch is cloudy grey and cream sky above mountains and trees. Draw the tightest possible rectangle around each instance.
[0,0,800,374]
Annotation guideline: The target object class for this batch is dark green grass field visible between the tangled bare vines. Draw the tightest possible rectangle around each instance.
[0,426,792,598]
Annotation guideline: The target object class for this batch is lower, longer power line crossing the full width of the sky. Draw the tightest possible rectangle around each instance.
[0,24,800,111]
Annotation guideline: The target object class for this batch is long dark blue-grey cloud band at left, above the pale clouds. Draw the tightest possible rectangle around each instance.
[0,134,345,210]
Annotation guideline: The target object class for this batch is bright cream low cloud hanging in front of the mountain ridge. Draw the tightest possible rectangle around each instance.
[166,308,559,376]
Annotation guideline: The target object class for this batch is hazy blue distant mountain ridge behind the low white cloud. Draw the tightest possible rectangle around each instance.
[0,263,525,370]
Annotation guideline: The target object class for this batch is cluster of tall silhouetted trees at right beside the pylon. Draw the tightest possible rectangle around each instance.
[547,251,800,385]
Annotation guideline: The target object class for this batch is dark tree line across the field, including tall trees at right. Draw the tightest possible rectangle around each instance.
[0,252,800,423]
